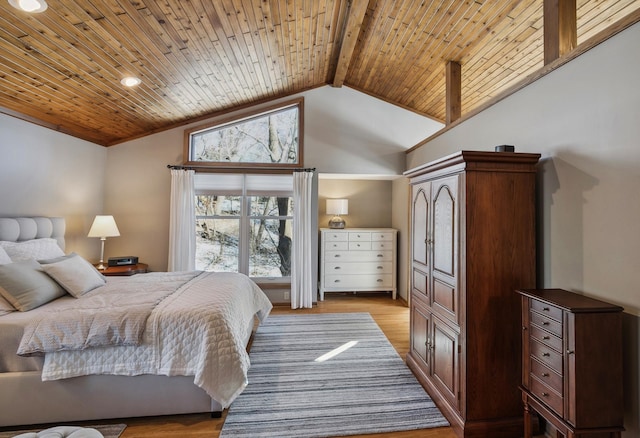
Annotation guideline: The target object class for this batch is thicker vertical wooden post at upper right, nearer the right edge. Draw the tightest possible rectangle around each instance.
[543,0,578,65]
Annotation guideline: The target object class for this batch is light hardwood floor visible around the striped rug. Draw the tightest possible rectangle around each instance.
[40,293,456,438]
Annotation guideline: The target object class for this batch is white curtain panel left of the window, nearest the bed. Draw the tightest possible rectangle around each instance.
[169,169,196,271]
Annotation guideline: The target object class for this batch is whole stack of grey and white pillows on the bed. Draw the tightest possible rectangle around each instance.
[0,238,106,316]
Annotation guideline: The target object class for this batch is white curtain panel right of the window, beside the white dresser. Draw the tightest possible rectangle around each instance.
[291,171,315,309]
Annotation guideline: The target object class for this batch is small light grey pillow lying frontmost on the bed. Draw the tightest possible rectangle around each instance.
[41,253,107,298]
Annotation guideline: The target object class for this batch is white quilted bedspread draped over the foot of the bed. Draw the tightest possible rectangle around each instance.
[37,272,272,408]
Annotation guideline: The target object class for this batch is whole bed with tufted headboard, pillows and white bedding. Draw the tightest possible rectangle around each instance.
[0,217,271,426]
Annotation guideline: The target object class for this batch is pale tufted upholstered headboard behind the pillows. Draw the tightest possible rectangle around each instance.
[0,217,66,250]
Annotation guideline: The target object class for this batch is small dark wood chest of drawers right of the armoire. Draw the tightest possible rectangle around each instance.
[518,289,624,438]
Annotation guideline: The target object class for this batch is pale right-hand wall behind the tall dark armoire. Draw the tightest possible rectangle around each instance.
[407,24,640,438]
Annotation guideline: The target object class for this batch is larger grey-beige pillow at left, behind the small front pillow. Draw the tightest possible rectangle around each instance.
[0,260,65,312]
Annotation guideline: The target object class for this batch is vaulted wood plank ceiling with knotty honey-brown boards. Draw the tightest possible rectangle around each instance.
[0,0,640,146]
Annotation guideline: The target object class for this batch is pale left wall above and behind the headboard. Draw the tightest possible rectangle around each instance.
[0,114,107,261]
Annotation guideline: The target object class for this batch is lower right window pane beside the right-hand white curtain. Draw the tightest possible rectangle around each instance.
[249,219,293,277]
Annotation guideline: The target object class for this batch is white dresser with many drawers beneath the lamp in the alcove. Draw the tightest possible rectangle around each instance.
[320,228,398,301]
